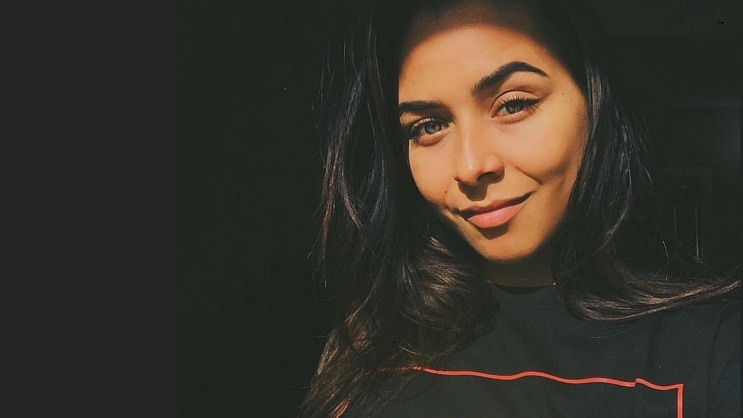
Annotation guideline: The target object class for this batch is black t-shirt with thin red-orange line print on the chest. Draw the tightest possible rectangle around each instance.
[342,286,741,418]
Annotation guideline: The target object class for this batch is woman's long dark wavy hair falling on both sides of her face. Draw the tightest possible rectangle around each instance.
[302,0,738,417]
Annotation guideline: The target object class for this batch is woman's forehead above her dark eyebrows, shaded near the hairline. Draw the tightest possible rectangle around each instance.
[398,2,563,101]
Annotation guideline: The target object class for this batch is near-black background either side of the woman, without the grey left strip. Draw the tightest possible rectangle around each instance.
[177,0,741,418]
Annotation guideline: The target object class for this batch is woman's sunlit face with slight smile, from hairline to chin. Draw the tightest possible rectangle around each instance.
[399,3,587,263]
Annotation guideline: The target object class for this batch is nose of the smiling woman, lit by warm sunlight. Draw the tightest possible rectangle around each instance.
[454,121,503,187]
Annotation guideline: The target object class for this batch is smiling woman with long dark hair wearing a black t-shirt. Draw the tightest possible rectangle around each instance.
[303,0,740,417]
